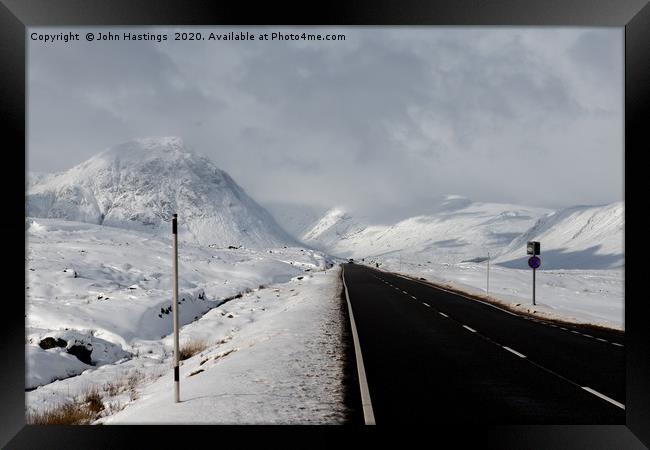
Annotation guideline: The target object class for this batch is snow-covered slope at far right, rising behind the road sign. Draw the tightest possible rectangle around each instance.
[497,202,625,269]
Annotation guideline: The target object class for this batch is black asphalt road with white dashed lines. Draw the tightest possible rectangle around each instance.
[343,264,625,425]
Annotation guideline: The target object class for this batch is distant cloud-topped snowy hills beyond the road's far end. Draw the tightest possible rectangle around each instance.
[303,196,549,263]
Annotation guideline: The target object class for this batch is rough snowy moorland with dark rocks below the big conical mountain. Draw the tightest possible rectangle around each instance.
[25,219,333,388]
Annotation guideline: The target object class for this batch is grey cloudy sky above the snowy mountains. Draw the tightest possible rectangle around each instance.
[28,27,624,220]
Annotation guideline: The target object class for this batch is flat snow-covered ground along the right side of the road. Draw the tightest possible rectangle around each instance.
[366,255,625,330]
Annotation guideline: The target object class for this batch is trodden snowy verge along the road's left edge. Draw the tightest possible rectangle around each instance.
[101,268,346,424]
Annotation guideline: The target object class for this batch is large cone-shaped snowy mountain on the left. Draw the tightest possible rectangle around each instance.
[26,137,295,248]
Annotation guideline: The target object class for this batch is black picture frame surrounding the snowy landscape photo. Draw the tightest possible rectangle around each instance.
[0,0,650,449]
